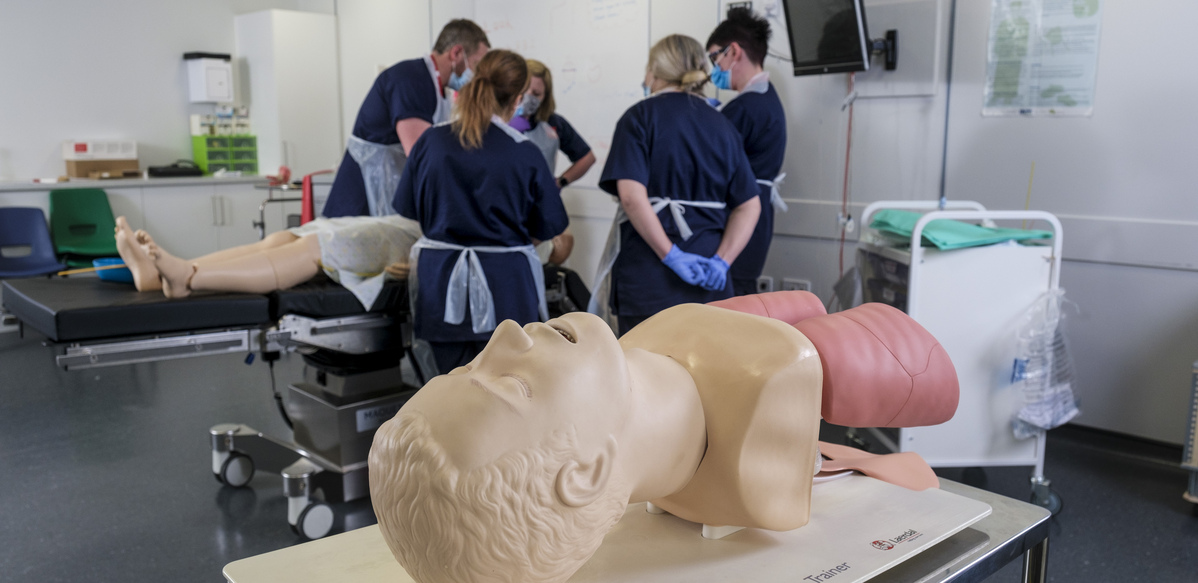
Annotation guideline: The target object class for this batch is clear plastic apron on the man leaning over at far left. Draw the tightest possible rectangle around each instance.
[345,56,452,217]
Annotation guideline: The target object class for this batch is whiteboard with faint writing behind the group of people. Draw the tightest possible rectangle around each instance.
[474,0,649,187]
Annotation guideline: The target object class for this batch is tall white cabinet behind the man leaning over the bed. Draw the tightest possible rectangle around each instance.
[235,10,345,177]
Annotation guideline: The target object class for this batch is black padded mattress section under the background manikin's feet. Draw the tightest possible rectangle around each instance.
[4,278,271,342]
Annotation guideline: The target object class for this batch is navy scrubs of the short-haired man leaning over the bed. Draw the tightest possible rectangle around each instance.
[321,57,438,217]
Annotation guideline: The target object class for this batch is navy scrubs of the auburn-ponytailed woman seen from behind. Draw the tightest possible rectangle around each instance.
[394,123,569,372]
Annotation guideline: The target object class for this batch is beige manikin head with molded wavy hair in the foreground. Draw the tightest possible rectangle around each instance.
[369,314,633,583]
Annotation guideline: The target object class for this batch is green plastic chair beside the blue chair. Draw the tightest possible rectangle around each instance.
[50,188,117,267]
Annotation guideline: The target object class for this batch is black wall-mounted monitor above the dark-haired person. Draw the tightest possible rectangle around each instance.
[782,0,872,75]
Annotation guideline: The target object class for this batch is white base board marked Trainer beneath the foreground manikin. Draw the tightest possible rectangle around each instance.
[224,475,991,583]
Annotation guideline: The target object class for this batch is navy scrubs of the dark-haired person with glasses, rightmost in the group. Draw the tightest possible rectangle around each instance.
[721,81,786,296]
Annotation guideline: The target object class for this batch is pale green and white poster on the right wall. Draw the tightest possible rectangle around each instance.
[981,0,1102,116]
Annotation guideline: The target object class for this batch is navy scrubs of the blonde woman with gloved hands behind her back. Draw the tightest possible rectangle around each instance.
[599,91,758,320]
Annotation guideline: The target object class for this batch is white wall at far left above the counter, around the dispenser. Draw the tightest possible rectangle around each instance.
[0,0,331,181]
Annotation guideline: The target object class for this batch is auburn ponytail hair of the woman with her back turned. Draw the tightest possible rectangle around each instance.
[453,49,528,150]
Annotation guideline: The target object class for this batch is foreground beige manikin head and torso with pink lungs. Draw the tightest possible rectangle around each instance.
[369,292,957,583]
